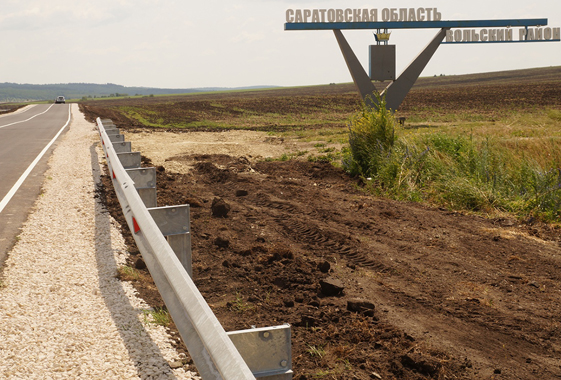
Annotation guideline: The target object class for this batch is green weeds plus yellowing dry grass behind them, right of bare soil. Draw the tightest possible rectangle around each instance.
[343,101,561,222]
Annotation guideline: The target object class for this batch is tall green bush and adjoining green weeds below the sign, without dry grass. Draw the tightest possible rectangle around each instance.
[342,99,561,221]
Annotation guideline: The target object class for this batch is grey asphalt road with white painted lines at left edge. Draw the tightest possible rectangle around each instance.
[0,104,70,268]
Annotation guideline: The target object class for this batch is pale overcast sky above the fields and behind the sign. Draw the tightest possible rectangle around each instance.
[0,0,561,88]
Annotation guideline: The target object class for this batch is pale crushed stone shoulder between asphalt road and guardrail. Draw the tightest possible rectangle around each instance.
[0,104,198,379]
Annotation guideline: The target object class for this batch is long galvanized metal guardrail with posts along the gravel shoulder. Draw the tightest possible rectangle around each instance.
[97,118,292,380]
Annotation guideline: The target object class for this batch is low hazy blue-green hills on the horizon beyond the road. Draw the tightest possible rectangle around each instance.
[0,83,278,103]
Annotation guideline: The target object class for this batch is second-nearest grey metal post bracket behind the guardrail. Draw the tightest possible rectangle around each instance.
[148,205,193,278]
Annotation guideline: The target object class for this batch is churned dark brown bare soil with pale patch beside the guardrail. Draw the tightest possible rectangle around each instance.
[86,70,561,379]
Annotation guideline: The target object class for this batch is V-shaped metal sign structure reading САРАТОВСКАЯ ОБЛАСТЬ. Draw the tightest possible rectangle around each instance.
[284,8,561,110]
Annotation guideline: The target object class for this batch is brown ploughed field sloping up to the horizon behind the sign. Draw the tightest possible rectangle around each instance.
[82,66,561,132]
